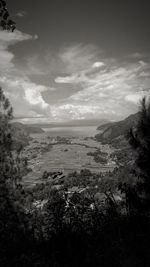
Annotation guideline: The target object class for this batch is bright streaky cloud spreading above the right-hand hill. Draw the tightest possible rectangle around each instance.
[70,63,150,109]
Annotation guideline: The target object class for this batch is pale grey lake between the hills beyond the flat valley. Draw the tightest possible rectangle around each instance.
[43,126,99,137]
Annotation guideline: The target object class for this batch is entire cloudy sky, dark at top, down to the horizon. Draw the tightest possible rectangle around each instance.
[0,0,150,123]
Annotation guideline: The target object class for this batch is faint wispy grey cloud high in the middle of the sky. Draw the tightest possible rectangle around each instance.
[55,44,105,84]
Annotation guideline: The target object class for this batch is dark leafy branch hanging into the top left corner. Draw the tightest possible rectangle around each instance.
[0,0,16,32]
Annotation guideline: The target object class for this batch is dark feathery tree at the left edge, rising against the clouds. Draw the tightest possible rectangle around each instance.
[0,88,27,189]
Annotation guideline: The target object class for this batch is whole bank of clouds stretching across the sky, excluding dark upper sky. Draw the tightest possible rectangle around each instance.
[0,37,150,122]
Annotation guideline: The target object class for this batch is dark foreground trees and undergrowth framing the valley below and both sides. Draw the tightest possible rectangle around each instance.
[0,86,150,267]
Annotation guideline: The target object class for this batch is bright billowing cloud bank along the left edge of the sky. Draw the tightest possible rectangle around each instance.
[0,30,54,120]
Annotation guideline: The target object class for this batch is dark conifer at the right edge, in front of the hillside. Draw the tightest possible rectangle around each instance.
[127,98,150,207]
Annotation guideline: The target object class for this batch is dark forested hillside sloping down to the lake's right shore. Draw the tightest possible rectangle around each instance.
[95,112,140,148]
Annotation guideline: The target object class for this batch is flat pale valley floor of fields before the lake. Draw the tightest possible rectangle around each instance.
[23,134,116,186]
